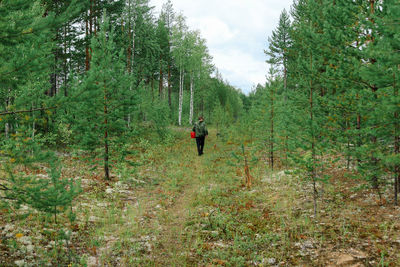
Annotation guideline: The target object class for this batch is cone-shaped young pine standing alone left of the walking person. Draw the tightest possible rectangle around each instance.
[70,15,134,180]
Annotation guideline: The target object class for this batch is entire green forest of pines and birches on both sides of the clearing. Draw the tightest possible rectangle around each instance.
[0,0,400,266]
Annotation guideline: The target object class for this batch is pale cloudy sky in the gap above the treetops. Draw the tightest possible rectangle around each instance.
[150,0,293,94]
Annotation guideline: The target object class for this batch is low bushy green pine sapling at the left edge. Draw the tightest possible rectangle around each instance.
[0,128,81,223]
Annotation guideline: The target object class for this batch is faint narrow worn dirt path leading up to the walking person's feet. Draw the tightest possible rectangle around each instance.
[144,133,211,266]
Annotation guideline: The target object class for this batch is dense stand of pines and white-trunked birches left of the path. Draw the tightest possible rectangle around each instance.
[0,0,245,182]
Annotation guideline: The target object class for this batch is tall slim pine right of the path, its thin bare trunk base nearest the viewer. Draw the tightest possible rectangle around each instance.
[288,1,330,215]
